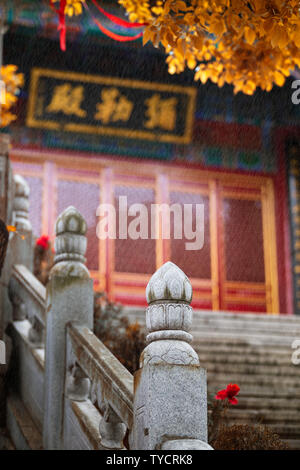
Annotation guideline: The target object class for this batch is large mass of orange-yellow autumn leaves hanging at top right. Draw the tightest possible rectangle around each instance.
[118,0,300,95]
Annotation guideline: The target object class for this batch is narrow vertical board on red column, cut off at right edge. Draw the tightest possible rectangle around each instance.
[287,140,300,314]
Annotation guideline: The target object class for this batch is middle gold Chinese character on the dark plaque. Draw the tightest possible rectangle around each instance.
[94,88,133,124]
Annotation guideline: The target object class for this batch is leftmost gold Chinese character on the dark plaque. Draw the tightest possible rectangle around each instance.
[46,83,86,117]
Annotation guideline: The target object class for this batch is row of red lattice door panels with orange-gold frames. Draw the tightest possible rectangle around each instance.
[13,155,279,313]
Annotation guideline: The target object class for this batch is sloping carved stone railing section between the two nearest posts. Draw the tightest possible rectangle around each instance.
[65,324,133,449]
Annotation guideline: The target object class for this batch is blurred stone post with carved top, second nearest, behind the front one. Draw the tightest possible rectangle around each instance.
[43,207,94,449]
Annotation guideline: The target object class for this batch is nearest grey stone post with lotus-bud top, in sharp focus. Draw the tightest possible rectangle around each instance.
[130,262,211,450]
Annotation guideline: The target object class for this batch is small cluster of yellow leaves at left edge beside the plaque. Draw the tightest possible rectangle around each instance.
[0,65,24,127]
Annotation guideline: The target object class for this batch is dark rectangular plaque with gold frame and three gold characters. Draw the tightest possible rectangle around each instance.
[27,69,196,144]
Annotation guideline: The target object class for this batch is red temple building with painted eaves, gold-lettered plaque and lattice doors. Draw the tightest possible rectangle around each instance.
[3,0,300,314]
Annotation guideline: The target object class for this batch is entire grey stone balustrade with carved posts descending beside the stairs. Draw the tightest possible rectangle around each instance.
[2,173,210,450]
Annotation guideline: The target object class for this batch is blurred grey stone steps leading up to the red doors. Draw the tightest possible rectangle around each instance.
[125,309,300,449]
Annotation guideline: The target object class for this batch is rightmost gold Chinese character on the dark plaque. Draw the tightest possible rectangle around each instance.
[145,94,177,131]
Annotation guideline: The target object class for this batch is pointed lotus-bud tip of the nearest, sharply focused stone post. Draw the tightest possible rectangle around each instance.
[146,261,193,304]
